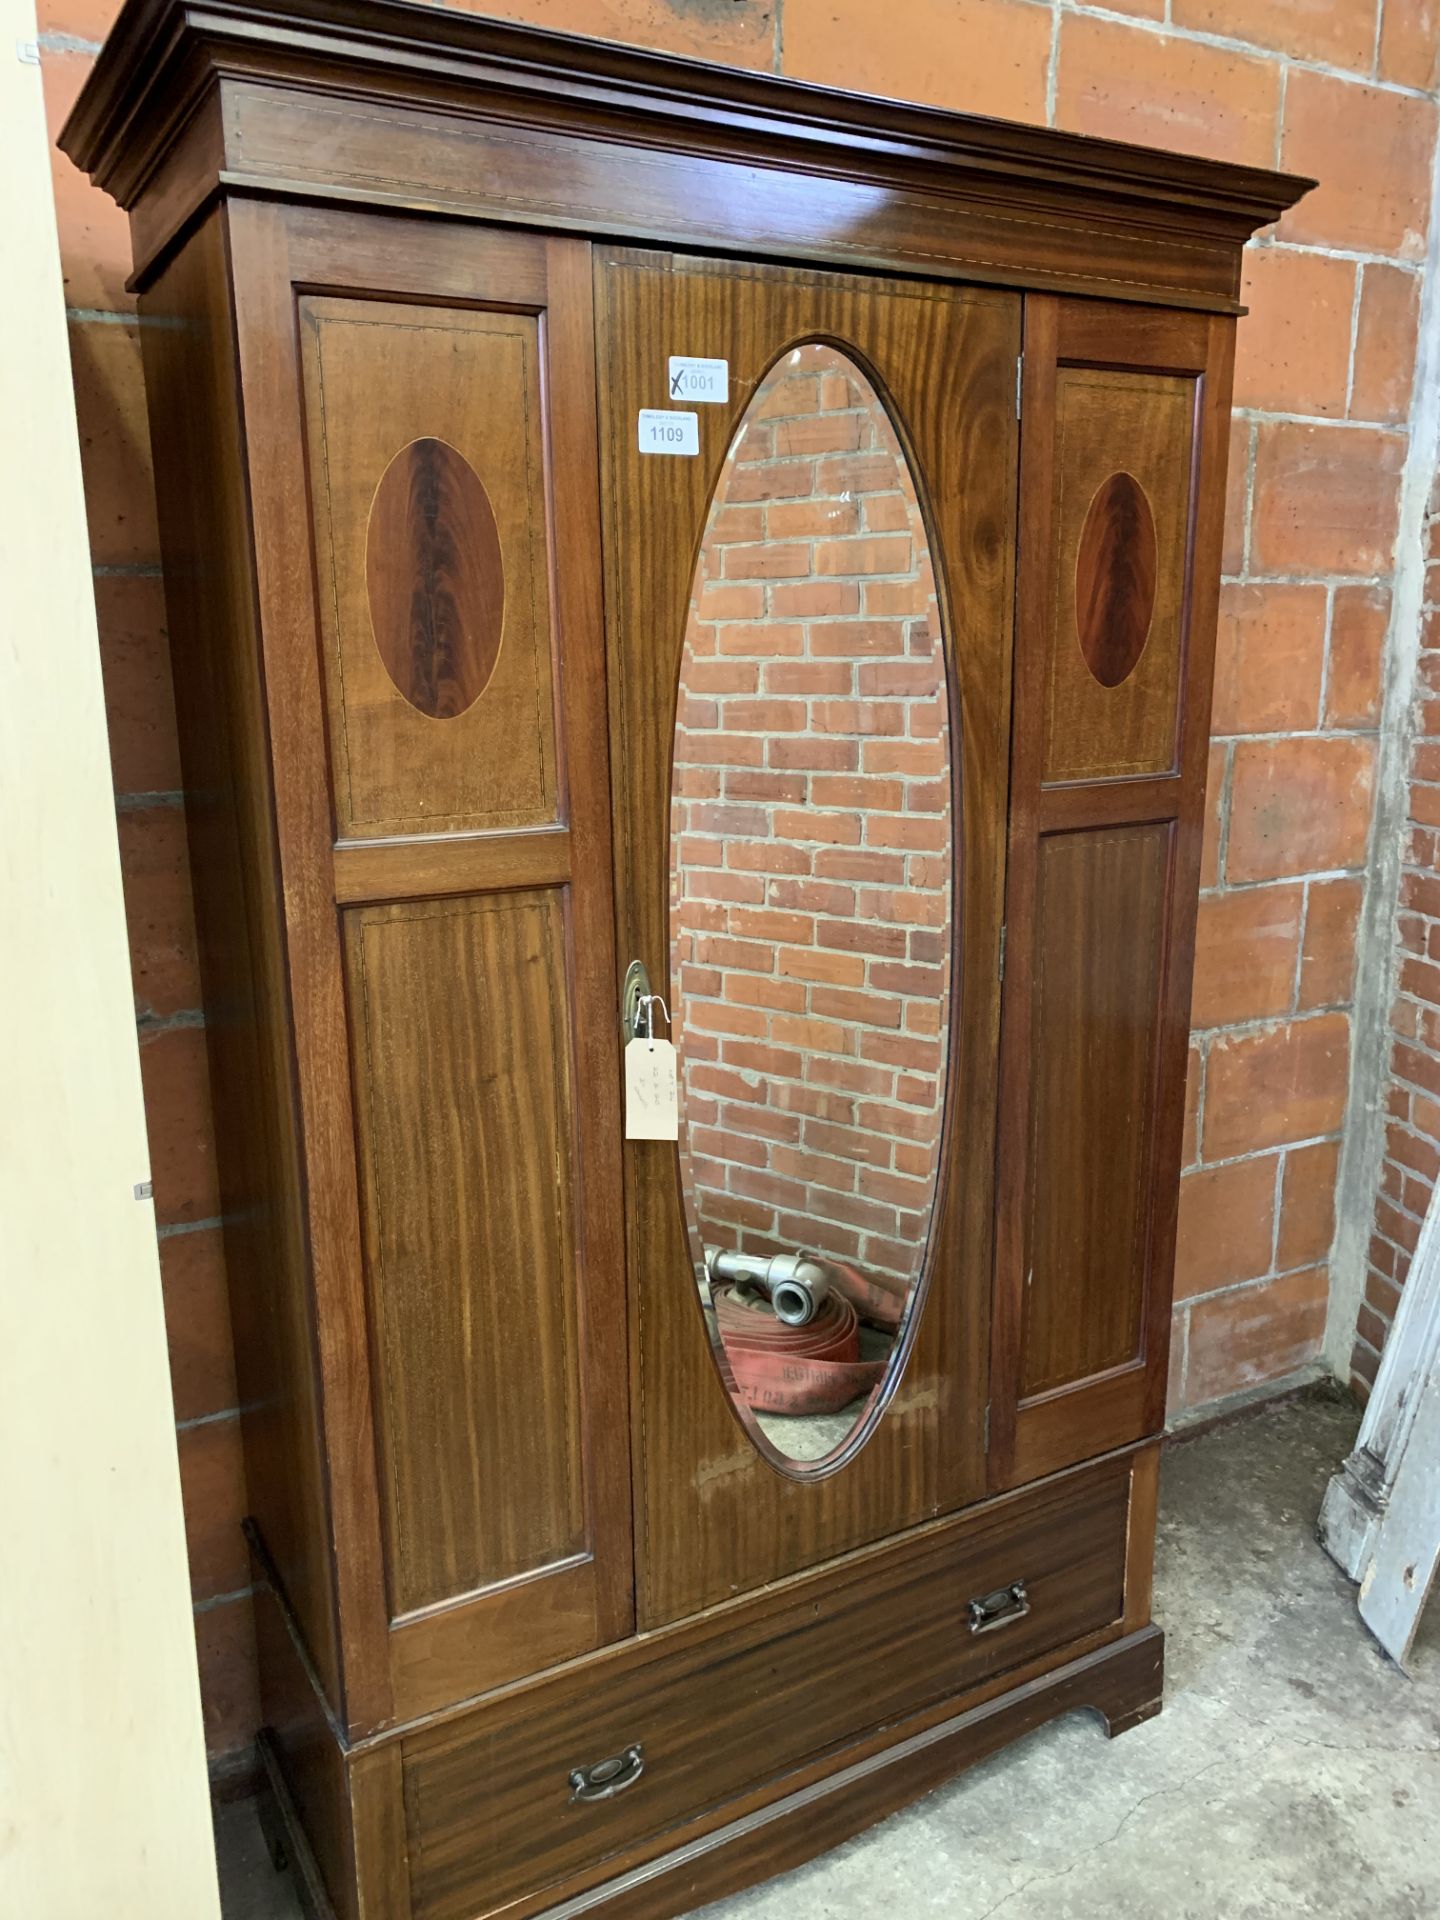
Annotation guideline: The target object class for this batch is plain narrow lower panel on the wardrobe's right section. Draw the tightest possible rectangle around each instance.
[1020,822,1171,1398]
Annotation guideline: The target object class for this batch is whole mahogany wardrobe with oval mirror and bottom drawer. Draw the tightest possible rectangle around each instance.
[61,15,1308,1920]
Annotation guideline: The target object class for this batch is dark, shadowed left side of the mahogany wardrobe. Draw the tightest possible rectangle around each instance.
[140,213,340,1707]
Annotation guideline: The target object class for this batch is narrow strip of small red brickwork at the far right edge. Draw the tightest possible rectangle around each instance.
[1350,474,1440,1396]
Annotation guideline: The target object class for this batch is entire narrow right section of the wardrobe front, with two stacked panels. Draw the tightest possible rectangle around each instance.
[991,296,1233,1486]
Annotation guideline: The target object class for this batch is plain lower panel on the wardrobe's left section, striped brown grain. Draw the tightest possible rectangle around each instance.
[346,891,586,1615]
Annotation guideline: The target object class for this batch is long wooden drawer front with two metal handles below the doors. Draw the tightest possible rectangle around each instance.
[403,1461,1129,1920]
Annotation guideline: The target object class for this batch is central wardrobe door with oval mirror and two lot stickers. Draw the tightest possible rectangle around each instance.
[595,252,1020,1626]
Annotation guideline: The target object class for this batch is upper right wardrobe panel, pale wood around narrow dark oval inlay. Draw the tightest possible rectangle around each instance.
[1043,367,1196,781]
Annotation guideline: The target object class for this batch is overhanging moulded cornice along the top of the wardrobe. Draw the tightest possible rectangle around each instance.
[61,0,1311,313]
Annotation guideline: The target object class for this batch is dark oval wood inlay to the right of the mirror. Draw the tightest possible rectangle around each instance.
[1075,472,1158,687]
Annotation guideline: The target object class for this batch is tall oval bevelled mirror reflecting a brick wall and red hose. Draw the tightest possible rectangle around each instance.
[670,342,954,1471]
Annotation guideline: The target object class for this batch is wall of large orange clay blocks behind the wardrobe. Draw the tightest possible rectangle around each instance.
[40,0,1440,1757]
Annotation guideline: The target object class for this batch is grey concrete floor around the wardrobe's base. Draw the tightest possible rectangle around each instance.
[217,1398,1440,1920]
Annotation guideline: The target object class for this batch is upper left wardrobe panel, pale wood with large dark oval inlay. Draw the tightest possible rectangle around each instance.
[300,298,559,839]
